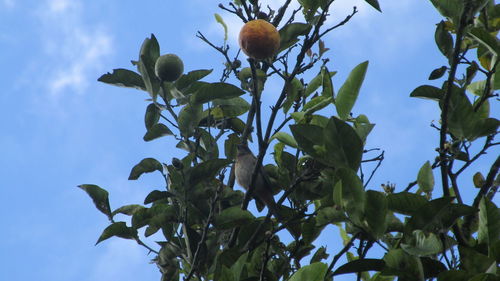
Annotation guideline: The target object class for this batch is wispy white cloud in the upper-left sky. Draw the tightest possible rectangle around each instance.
[38,0,113,97]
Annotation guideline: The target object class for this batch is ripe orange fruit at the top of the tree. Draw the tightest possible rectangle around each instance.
[238,19,280,60]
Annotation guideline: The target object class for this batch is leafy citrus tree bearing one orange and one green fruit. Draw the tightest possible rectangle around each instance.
[80,0,500,281]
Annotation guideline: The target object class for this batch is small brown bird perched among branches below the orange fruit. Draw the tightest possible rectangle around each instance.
[235,144,281,219]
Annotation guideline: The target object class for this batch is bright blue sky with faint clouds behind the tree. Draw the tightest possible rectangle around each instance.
[0,0,498,281]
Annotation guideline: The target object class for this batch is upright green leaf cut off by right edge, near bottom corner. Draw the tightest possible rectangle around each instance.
[477,198,500,252]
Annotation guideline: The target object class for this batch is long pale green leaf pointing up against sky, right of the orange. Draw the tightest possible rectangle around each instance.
[335,61,368,120]
